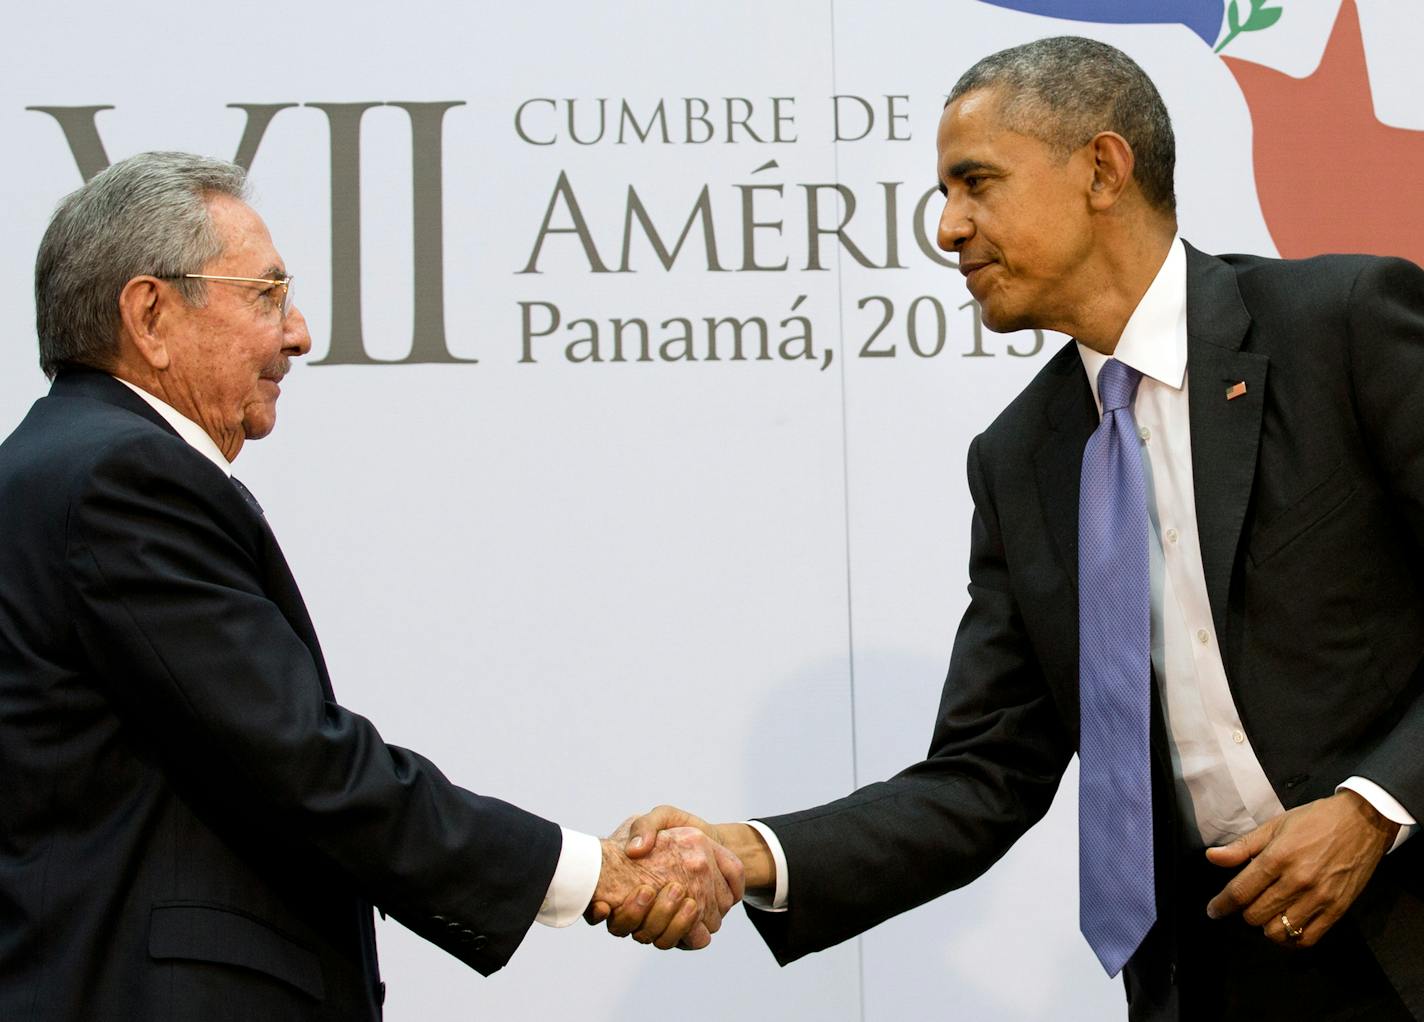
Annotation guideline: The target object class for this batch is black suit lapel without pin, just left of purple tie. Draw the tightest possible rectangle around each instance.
[1034,342,1098,589]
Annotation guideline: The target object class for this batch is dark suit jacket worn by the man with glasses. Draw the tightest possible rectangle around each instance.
[0,372,560,1022]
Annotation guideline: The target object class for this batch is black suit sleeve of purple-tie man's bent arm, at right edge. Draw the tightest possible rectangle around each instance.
[1349,259,1424,820]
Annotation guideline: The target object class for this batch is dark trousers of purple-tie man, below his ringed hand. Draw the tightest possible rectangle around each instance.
[1124,851,1414,1022]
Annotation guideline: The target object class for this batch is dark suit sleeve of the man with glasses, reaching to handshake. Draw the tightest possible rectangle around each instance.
[66,436,560,974]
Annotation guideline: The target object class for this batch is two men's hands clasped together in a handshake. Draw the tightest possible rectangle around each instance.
[584,806,776,951]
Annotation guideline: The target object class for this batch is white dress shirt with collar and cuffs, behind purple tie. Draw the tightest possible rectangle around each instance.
[753,238,1415,910]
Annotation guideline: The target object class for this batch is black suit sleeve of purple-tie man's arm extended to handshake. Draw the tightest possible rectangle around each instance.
[749,437,1075,965]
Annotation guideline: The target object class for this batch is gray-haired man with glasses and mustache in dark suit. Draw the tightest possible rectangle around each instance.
[0,154,740,1022]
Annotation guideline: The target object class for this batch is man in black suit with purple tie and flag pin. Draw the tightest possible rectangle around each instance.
[611,38,1424,1021]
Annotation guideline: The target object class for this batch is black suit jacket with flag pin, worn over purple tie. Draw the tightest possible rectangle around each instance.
[752,248,1424,1018]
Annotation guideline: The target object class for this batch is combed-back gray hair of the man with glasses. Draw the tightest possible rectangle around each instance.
[34,152,246,379]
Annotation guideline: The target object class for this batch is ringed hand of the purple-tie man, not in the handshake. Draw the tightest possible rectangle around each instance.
[1206,790,1400,948]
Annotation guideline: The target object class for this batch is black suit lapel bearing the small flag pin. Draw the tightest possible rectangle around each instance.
[1186,245,1269,642]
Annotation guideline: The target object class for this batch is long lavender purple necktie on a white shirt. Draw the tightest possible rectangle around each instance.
[1078,359,1156,976]
